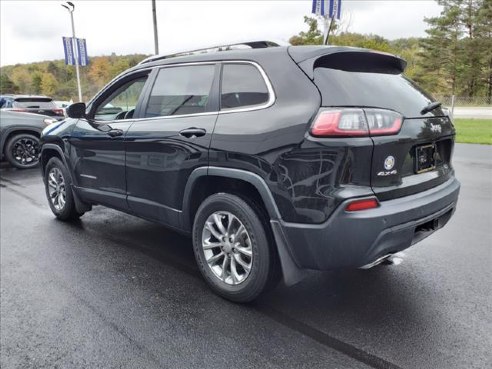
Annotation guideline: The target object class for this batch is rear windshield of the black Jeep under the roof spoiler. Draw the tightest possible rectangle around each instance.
[314,68,442,118]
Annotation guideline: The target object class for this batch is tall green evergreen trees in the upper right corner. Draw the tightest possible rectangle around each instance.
[420,0,492,96]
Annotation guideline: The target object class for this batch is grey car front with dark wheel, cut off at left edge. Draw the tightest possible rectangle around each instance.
[0,110,57,169]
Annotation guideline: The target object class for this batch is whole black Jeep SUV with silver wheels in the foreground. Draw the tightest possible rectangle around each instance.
[41,43,460,302]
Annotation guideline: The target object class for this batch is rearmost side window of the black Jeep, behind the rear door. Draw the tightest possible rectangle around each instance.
[220,64,268,110]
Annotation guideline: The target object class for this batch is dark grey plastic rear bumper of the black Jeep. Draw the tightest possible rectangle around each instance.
[272,178,460,270]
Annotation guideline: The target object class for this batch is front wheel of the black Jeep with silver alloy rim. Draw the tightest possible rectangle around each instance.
[44,157,83,221]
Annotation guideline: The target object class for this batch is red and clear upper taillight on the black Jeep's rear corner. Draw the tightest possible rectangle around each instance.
[311,108,403,137]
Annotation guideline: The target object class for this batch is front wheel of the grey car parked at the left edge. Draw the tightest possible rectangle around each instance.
[5,133,39,169]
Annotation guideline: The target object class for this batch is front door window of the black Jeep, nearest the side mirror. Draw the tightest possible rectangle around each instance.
[95,76,147,120]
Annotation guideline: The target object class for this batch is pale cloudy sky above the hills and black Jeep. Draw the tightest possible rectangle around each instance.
[0,0,441,66]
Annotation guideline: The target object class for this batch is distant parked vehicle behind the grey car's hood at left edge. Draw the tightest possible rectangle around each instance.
[0,95,65,120]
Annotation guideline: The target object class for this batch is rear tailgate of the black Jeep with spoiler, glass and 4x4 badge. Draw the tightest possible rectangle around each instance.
[291,47,455,201]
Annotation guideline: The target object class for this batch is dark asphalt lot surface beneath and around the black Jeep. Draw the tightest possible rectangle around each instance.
[0,144,492,369]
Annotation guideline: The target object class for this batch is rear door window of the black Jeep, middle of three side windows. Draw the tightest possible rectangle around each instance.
[145,65,215,117]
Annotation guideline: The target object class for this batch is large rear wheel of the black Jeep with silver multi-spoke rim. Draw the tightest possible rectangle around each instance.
[193,193,277,302]
